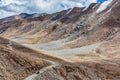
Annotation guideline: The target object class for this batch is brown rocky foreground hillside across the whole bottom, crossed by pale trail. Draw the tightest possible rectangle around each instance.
[0,38,120,80]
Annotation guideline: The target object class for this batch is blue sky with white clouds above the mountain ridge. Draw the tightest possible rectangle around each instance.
[0,0,104,18]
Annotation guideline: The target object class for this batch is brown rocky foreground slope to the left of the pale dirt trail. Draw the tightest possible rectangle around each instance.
[0,38,66,80]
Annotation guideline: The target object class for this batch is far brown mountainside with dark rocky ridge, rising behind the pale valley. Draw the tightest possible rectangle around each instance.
[0,0,119,53]
